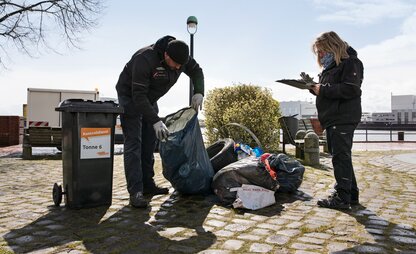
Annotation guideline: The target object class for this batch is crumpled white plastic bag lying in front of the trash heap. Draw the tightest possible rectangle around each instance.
[230,184,276,210]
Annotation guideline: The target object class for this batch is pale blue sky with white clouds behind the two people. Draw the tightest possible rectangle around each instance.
[0,0,416,116]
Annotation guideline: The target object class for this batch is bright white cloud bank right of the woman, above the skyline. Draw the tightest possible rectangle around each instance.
[358,12,416,112]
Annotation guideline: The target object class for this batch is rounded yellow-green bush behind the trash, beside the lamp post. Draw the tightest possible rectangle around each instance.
[204,84,280,152]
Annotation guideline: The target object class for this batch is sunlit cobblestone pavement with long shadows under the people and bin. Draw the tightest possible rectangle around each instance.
[0,146,416,253]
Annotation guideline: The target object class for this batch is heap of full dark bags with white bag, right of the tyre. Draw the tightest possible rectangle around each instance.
[212,146,305,210]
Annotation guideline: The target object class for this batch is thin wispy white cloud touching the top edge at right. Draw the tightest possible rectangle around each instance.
[314,0,416,24]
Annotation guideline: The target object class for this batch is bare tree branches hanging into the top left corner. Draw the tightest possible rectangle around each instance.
[0,0,104,68]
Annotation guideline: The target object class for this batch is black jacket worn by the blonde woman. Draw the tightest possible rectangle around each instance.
[316,47,364,128]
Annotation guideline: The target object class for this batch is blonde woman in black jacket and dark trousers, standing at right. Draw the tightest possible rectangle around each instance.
[310,31,364,209]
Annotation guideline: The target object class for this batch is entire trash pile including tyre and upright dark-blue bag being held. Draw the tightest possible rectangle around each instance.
[159,108,305,210]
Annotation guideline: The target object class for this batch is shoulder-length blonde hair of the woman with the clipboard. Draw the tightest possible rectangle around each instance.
[312,31,349,67]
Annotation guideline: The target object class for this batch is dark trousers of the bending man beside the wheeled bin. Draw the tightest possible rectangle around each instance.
[119,97,157,195]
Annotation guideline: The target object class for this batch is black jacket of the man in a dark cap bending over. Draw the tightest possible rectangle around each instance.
[116,36,204,124]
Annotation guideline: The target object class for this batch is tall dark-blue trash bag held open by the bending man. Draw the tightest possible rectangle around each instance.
[159,108,214,194]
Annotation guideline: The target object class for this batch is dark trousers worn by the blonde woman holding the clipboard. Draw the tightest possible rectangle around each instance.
[326,124,359,202]
